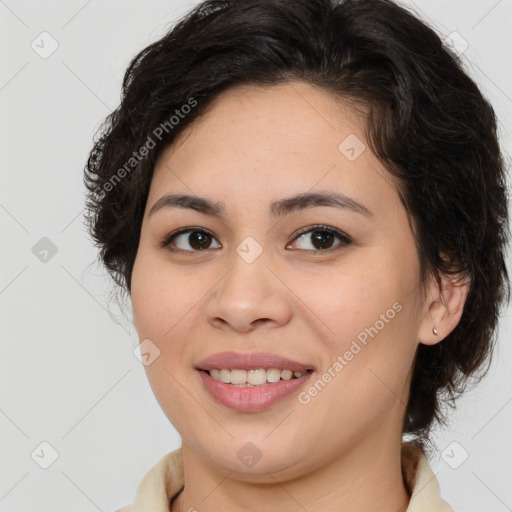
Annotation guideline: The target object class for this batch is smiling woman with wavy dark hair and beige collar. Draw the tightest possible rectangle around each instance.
[85,0,509,512]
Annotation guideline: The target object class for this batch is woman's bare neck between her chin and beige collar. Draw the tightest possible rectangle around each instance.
[171,432,409,512]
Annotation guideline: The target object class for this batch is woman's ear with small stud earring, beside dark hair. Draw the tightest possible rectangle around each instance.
[418,274,470,345]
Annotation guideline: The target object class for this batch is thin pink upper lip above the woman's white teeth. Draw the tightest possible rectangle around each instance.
[196,352,314,372]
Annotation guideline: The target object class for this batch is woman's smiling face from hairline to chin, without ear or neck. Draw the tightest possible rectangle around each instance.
[131,82,432,481]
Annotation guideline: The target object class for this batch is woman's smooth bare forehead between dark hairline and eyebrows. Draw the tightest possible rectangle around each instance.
[150,82,398,220]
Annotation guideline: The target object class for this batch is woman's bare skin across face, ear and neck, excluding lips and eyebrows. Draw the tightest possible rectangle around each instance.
[131,82,467,512]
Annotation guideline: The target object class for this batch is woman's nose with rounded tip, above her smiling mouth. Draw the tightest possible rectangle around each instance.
[204,247,291,332]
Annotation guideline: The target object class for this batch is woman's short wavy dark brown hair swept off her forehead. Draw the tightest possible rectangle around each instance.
[84,0,510,442]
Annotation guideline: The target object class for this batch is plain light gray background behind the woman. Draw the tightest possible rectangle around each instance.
[0,0,512,512]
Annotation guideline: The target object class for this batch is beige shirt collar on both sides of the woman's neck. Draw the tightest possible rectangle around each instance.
[116,443,454,512]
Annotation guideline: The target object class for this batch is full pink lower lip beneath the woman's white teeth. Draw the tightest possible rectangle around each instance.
[199,370,313,412]
